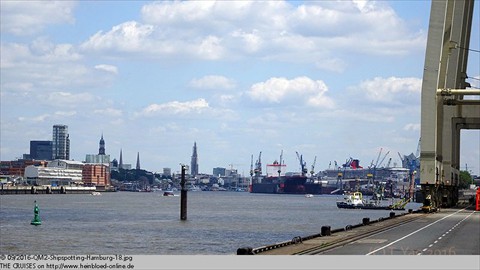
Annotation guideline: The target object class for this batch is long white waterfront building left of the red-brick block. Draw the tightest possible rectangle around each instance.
[24,159,84,186]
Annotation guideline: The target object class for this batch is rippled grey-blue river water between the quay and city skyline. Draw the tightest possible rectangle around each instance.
[0,192,419,255]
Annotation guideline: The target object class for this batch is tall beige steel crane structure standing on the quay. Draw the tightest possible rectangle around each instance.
[420,0,480,209]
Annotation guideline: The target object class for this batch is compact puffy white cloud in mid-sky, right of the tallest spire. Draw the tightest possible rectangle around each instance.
[246,77,334,108]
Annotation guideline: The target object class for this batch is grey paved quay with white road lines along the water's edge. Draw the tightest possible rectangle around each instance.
[237,207,480,255]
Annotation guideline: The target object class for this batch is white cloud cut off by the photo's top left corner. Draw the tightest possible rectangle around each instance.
[0,1,76,36]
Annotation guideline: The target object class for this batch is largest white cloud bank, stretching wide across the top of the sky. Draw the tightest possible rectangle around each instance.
[82,1,426,67]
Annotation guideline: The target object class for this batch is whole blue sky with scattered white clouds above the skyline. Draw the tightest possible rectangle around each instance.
[0,0,480,176]
